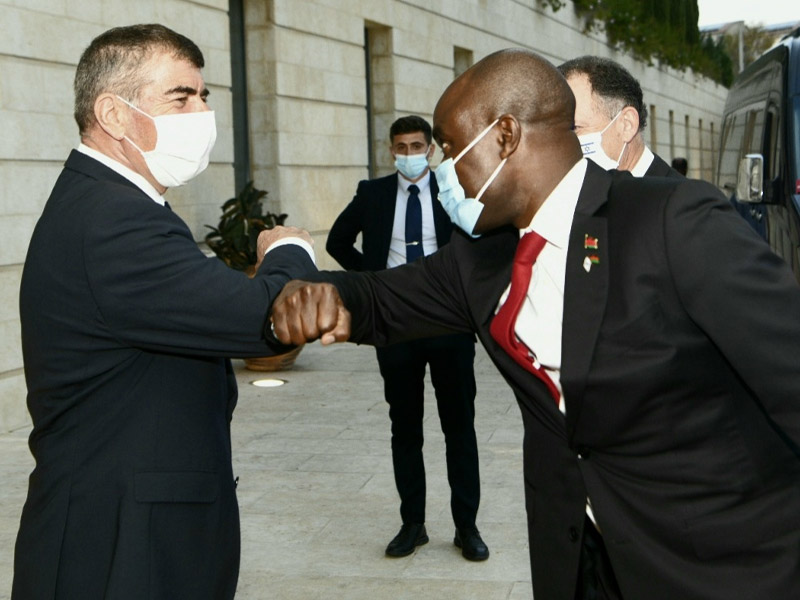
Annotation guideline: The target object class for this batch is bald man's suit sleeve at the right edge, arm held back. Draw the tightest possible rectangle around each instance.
[665,181,800,448]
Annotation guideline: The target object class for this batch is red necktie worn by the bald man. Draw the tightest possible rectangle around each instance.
[489,231,561,404]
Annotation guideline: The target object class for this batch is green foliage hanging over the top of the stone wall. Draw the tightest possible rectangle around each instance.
[539,0,733,87]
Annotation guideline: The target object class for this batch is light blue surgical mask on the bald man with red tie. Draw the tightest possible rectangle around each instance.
[434,119,507,238]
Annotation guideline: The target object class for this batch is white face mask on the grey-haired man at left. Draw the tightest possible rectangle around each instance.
[117,96,217,187]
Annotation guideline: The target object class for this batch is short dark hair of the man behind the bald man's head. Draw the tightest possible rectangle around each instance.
[558,56,647,131]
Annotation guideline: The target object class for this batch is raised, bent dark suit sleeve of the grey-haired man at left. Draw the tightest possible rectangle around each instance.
[83,199,316,356]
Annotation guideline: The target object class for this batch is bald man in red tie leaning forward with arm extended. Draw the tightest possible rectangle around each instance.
[272,50,800,600]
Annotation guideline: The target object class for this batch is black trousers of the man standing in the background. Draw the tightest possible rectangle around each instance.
[376,334,480,527]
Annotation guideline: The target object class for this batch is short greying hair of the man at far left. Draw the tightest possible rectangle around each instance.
[73,24,205,134]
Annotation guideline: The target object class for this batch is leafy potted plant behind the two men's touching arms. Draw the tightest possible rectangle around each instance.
[205,181,302,371]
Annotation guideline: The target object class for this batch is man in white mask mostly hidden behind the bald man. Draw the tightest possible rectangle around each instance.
[558,56,680,177]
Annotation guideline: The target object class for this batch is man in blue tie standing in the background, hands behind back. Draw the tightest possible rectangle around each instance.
[326,115,489,560]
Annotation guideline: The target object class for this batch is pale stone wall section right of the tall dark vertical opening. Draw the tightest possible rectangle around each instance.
[252,0,727,268]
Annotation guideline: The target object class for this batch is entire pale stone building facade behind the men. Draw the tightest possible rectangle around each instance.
[0,0,727,430]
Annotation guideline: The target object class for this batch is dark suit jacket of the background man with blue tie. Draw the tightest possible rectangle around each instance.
[325,172,453,271]
